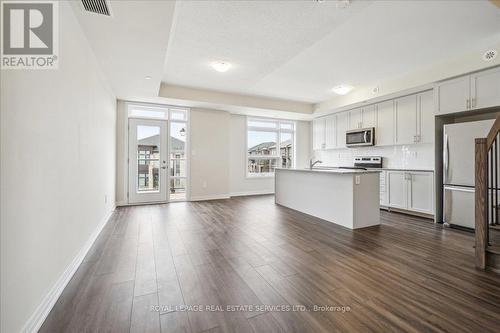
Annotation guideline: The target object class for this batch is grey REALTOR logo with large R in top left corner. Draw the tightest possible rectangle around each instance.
[1,1,58,69]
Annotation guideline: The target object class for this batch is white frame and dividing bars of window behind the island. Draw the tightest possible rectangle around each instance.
[245,116,297,179]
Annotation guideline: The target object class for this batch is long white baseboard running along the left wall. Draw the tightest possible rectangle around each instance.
[21,207,116,333]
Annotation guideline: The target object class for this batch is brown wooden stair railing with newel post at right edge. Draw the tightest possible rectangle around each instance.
[475,116,500,273]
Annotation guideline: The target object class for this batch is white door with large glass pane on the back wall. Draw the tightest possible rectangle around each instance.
[128,118,169,204]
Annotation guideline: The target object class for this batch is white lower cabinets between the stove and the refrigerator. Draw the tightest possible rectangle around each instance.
[385,171,434,215]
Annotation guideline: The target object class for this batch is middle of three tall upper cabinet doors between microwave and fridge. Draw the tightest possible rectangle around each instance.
[394,95,417,144]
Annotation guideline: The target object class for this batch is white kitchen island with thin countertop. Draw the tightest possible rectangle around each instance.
[275,168,380,229]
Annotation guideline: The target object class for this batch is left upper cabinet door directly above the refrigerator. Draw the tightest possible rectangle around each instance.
[435,75,470,114]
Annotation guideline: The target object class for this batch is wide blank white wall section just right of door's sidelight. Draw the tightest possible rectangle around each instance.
[190,109,231,200]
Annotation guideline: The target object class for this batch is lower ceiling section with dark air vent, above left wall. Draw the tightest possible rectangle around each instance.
[68,1,175,100]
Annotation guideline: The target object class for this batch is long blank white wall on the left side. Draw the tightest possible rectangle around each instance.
[0,2,116,332]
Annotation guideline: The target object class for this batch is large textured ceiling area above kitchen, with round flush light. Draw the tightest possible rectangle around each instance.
[162,0,500,103]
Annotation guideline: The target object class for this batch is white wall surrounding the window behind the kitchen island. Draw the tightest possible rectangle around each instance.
[229,114,311,195]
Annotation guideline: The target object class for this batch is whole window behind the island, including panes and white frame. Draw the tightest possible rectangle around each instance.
[246,118,295,177]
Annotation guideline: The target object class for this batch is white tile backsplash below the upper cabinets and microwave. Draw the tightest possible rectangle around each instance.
[313,144,434,170]
